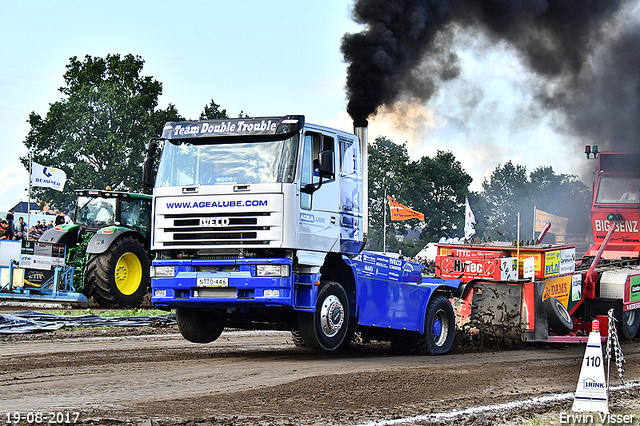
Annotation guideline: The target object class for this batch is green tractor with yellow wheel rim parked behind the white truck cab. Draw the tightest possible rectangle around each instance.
[39,190,151,308]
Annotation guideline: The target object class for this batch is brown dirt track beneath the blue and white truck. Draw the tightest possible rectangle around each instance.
[0,327,640,425]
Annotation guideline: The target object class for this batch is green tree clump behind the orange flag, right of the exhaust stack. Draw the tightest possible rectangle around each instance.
[369,137,471,256]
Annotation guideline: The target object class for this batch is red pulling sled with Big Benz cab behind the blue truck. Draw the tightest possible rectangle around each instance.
[436,148,640,342]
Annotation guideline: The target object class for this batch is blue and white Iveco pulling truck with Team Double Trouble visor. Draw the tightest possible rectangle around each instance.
[144,115,461,355]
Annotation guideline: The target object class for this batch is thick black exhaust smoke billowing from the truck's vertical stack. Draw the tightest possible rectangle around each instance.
[341,0,640,150]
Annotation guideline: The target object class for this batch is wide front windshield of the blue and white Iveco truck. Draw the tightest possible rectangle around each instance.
[156,135,298,187]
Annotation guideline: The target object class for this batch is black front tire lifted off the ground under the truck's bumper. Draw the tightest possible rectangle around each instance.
[176,308,224,343]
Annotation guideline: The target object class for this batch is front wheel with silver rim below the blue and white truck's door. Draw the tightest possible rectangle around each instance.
[298,281,349,351]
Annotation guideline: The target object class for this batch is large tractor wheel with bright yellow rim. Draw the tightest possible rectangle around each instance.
[86,236,150,308]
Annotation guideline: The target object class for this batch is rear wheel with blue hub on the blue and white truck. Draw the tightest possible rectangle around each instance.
[412,293,456,355]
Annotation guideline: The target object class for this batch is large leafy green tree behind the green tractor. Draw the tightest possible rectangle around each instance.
[21,54,182,210]
